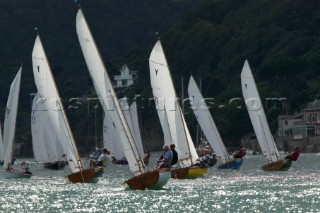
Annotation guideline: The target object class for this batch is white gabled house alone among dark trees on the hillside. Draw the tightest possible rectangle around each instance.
[114,64,137,88]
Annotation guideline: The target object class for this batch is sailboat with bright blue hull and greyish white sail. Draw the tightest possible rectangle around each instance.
[188,76,243,169]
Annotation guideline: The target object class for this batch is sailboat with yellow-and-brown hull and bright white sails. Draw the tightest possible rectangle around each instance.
[149,40,208,178]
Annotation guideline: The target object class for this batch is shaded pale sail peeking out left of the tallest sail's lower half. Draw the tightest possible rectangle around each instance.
[103,113,124,160]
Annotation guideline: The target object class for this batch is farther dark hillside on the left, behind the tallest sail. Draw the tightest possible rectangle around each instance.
[0,0,196,154]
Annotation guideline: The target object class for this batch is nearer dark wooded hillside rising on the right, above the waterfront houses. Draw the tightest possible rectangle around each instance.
[127,0,320,146]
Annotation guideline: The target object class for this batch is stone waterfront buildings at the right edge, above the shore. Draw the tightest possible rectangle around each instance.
[278,100,320,140]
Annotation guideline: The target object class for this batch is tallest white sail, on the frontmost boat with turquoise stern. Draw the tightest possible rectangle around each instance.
[76,9,146,175]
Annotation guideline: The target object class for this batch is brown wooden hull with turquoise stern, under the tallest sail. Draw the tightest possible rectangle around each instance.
[124,170,170,190]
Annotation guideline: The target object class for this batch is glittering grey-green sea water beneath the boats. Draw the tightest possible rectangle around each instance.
[0,154,320,213]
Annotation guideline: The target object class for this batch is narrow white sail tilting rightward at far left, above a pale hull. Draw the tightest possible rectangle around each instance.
[3,67,22,169]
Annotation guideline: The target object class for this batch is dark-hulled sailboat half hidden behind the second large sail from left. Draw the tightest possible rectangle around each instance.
[31,93,66,170]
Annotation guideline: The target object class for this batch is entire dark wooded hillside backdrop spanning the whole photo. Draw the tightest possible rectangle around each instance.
[0,0,320,154]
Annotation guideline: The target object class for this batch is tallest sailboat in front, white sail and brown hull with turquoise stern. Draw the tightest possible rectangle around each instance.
[76,9,170,190]
